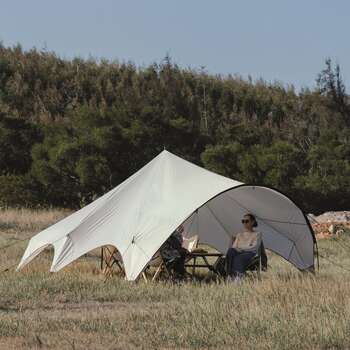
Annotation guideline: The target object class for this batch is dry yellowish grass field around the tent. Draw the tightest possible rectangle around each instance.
[0,210,350,350]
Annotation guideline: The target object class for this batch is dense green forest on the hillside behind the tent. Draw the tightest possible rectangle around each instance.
[0,44,350,213]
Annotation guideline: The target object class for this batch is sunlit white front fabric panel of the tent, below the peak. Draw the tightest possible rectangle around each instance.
[47,151,241,280]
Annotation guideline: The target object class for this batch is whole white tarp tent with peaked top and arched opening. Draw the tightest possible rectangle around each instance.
[18,151,315,280]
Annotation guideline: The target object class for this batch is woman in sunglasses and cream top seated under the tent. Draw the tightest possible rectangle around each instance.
[226,214,262,282]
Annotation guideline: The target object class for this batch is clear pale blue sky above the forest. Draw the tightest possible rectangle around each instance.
[0,0,350,90]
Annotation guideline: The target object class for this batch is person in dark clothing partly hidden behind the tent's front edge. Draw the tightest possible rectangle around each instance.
[160,225,188,276]
